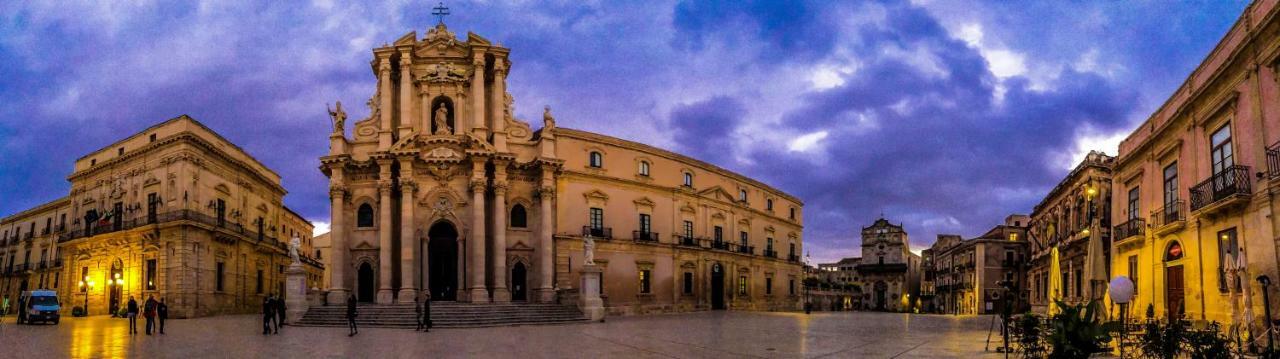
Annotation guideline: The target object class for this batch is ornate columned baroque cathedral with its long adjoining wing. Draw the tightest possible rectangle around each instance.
[320,22,803,314]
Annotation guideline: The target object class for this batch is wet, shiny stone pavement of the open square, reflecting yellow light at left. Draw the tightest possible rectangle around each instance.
[0,312,1018,358]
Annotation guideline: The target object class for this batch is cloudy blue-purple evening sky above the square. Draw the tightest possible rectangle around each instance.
[0,0,1247,262]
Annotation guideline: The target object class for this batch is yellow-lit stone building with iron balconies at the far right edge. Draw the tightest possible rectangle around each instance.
[1111,1,1280,325]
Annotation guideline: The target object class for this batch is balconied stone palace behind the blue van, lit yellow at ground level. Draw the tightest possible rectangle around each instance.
[0,115,323,318]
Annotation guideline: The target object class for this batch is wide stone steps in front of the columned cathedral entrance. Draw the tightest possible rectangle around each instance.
[294,301,588,328]
